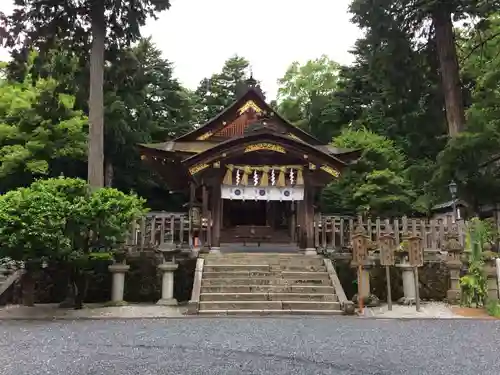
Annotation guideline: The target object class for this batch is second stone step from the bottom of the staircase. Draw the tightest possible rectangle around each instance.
[200,293,338,302]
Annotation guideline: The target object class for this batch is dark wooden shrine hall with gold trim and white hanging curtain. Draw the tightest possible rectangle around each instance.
[139,78,360,250]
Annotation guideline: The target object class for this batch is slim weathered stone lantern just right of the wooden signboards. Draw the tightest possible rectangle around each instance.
[444,223,464,304]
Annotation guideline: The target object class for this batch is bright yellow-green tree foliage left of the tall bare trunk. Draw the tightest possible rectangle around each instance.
[0,74,87,191]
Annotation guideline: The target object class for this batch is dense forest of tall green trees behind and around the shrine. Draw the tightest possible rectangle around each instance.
[0,0,500,216]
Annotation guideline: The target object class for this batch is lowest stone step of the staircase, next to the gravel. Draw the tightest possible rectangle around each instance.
[199,301,340,311]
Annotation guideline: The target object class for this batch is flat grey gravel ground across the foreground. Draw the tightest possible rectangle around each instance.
[0,317,500,375]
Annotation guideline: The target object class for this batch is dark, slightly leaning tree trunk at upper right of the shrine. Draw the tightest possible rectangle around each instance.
[432,7,465,137]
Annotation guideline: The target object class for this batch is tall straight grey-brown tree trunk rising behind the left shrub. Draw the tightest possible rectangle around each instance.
[88,0,106,188]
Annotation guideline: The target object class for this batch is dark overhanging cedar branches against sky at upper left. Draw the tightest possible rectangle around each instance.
[0,0,170,78]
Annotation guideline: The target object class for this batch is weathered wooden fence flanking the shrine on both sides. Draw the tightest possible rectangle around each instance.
[127,212,465,250]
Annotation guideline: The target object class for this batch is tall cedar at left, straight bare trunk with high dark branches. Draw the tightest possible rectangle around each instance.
[0,0,170,187]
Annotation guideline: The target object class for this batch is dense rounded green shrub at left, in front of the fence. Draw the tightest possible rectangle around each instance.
[0,178,145,260]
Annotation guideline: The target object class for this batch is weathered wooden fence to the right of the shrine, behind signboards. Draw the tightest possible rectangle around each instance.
[314,214,465,250]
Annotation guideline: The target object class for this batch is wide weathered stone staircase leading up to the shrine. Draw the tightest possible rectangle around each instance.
[193,253,345,315]
